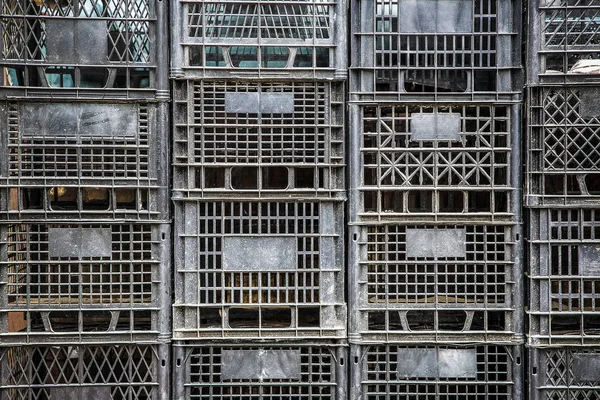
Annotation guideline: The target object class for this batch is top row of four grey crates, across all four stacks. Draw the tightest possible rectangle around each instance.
[0,0,600,101]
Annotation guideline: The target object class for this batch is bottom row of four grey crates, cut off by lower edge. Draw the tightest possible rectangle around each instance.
[0,343,600,400]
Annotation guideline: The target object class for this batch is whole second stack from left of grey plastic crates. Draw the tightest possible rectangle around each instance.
[171,0,347,400]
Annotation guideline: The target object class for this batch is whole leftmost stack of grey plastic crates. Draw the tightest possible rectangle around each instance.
[0,0,171,399]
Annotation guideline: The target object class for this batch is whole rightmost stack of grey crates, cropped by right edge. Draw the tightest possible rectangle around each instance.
[525,0,600,400]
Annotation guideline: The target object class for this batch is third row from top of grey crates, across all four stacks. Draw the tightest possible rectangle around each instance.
[0,200,600,344]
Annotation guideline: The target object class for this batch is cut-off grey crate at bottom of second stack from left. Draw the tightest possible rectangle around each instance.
[173,344,348,400]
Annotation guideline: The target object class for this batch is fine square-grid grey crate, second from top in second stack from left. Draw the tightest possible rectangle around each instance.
[173,81,345,199]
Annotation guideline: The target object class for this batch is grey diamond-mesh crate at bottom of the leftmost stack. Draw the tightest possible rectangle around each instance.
[0,345,171,400]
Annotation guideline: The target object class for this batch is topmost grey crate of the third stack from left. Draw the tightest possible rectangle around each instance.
[350,0,523,102]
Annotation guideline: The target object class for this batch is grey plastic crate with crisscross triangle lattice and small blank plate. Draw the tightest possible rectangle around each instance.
[350,104,521,222]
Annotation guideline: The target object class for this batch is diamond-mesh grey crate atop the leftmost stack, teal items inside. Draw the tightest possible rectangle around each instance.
[0,0,169,99]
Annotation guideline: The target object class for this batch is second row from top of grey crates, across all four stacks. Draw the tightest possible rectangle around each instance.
[0,81,600,211]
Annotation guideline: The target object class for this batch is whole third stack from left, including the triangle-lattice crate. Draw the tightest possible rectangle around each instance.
[348,0,524,400]
